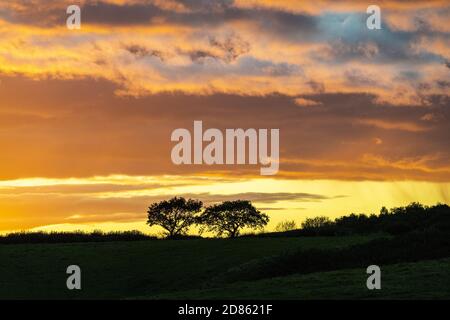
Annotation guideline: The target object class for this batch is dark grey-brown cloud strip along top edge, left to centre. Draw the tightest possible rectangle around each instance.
[0,0,317,39]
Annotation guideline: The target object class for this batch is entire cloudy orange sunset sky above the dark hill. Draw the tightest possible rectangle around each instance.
[0,0,450,233]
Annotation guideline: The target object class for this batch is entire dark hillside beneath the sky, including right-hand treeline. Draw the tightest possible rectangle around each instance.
[0,203,450,299]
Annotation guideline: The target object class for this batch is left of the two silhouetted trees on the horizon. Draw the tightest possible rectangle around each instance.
[147,197,203,238]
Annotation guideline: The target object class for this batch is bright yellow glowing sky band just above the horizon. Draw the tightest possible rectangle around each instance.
[0,175,450,233]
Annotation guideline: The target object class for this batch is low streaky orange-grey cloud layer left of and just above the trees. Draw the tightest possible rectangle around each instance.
[0,176,335,230]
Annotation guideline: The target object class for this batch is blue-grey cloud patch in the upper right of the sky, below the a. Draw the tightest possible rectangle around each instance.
[313,12,448,64]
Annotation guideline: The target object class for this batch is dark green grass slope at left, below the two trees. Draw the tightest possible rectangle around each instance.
[0,236,377,299]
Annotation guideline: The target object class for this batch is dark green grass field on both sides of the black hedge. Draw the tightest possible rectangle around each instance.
[0,235,450,299]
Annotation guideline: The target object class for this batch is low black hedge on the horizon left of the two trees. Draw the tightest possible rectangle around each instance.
[0,231,156,244]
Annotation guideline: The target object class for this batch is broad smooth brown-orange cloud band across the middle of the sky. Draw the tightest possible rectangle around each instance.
[0,77,450,181]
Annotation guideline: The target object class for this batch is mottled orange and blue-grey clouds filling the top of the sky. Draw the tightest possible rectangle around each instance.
[0,0,450,105]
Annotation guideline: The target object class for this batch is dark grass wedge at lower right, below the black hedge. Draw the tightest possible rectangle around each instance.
[142,258,450,300]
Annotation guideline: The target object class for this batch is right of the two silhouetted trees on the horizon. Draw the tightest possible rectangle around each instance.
[199,200,269,238]
